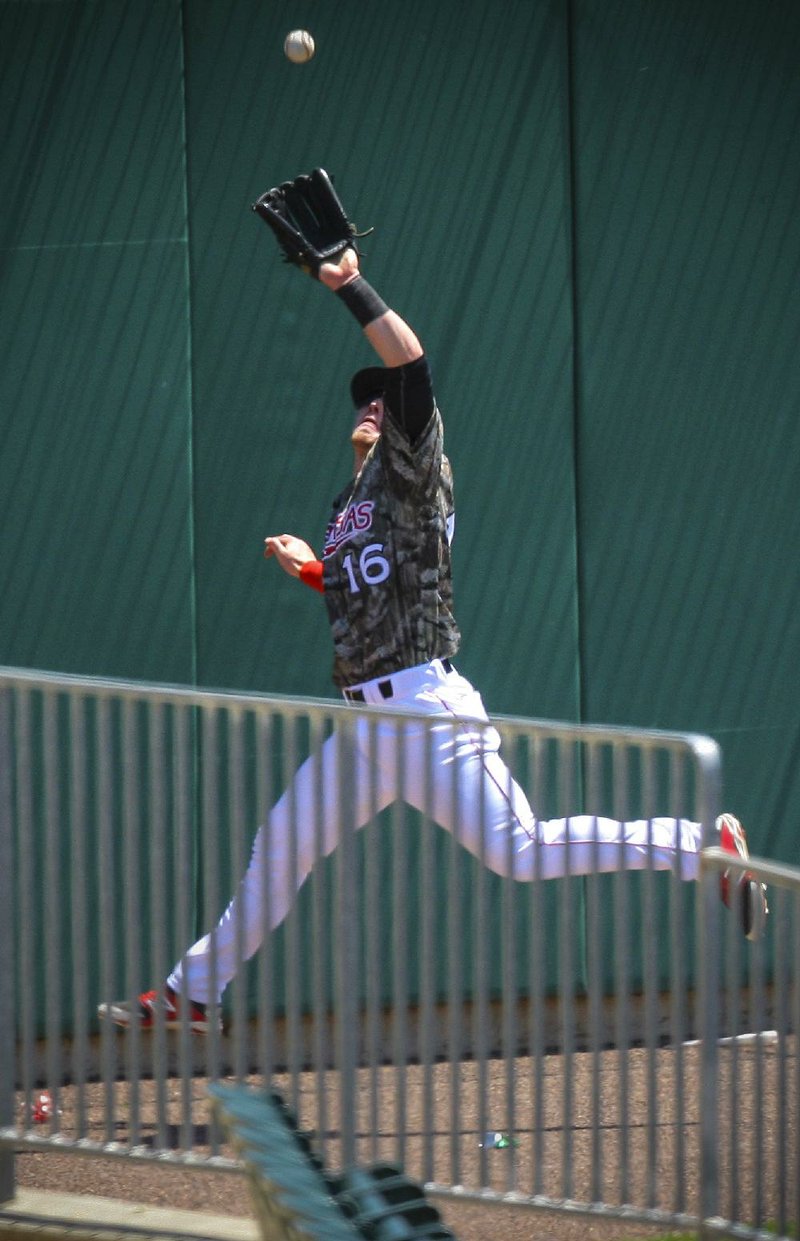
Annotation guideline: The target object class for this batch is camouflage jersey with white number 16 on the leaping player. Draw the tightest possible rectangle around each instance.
[322,362,460,686]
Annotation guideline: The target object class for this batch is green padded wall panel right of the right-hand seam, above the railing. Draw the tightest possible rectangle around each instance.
[576,0,800,862]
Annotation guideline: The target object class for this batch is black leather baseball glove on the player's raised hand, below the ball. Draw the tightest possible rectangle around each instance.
[253,168,372,278]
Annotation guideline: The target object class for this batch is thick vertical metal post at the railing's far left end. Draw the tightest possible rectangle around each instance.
[0,685,16,1203]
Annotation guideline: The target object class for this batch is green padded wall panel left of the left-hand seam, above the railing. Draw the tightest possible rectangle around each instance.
[0,0,193,681]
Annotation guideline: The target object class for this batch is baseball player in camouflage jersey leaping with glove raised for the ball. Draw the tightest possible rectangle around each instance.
[100,169,767,1033]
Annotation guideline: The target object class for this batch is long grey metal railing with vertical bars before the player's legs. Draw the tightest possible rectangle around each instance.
[0,669,800,1227]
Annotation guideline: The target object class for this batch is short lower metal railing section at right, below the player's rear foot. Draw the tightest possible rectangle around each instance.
[700,848,800,1236]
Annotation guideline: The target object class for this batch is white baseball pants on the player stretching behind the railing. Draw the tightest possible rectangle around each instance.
[167,660,702,1004]
